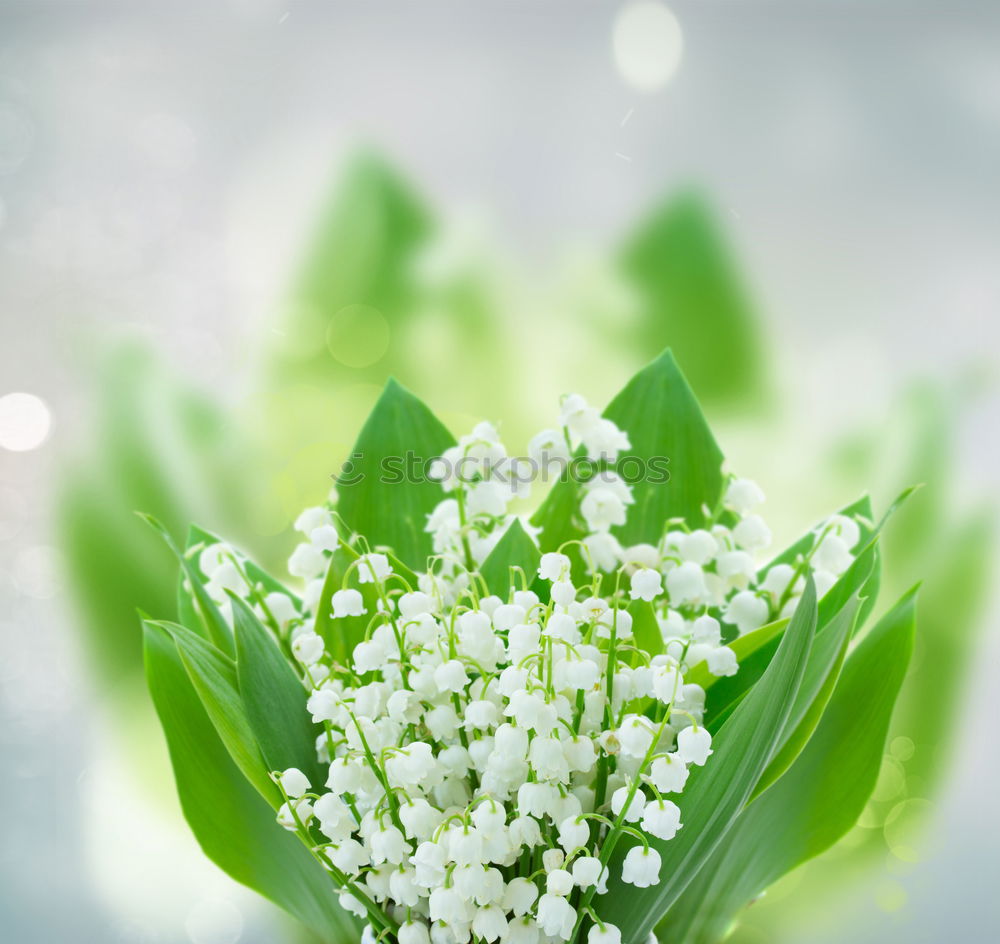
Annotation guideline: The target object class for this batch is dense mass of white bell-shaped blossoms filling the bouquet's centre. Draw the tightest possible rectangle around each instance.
[191,396,859,944]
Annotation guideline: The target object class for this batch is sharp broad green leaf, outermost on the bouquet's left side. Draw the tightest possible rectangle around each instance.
[144,623,360,944]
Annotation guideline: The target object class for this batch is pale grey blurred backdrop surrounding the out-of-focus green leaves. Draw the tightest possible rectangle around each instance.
[0,0,1000,944]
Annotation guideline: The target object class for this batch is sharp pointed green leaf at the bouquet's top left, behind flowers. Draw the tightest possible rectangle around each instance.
[337,380,455,570]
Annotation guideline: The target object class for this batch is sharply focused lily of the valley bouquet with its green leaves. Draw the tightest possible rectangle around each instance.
[144,353,914,944]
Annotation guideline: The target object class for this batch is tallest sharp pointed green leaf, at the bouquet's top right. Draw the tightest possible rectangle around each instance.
[532,350,723,550]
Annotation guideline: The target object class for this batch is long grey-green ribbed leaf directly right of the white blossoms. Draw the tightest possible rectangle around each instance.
[596,580,817,941]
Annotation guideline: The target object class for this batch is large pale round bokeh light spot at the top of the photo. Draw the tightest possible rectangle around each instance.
[612,0,684,92]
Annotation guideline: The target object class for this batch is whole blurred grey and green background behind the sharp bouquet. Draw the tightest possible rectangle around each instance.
[0,0,1000,944]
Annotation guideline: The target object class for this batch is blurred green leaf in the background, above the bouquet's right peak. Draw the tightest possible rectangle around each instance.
[619,192,766,409]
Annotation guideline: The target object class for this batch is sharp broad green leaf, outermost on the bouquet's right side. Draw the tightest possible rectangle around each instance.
[657,591,916,944]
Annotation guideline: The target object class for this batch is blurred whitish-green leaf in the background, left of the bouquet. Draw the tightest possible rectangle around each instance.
[56,344,254,692]
